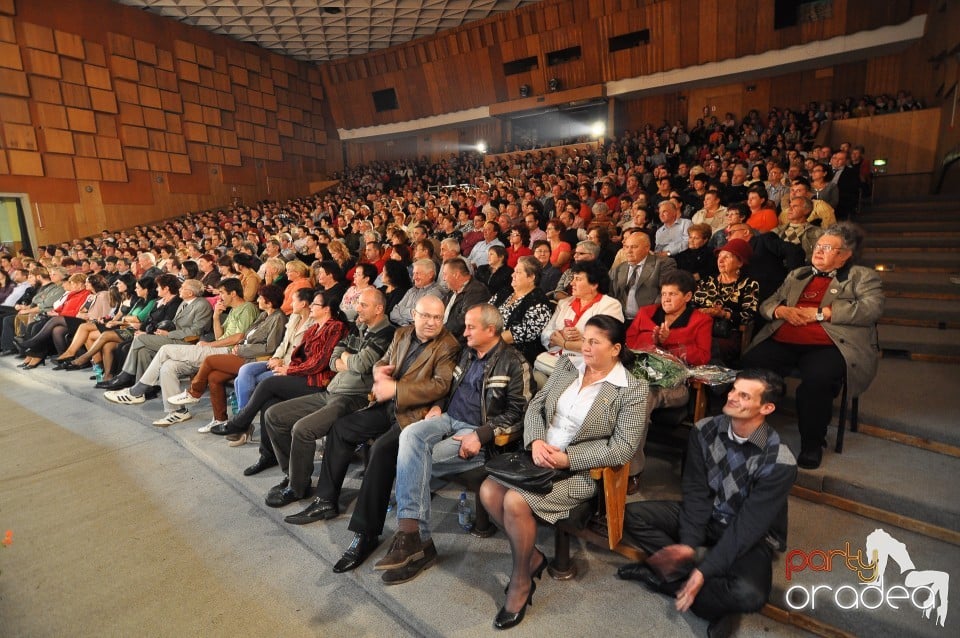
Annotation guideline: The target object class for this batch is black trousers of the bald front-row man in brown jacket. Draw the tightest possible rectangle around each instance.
[317,403,400,536]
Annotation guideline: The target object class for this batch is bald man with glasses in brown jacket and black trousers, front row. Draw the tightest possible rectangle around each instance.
[284,295,460,574]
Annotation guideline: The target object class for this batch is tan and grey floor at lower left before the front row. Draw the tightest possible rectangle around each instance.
[0,386,406,636]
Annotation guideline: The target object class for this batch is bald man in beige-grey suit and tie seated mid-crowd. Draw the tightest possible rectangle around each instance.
[610,231,677,324]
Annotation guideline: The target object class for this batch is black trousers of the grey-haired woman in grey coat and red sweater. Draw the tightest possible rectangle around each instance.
[740,339,847,451]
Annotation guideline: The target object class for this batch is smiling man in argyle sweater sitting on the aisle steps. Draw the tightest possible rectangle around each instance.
[617,370,797,637]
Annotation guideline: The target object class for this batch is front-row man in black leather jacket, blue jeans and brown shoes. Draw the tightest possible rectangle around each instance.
[375,303,531,585]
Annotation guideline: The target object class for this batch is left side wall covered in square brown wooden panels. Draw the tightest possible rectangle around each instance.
[0,0,335,242]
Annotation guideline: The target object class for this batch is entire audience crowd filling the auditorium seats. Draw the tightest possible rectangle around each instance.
[0,104,883,628]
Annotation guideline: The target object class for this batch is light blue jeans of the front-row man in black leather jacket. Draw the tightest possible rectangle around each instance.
[396,413,485,542]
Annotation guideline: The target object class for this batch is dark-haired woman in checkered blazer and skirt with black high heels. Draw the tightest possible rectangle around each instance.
[480,315,649,629]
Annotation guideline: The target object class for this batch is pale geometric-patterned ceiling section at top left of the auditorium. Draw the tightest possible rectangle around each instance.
[115,0,536,62]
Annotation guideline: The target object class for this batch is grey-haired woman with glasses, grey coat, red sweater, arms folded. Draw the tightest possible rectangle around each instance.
[741,222,884,469]
